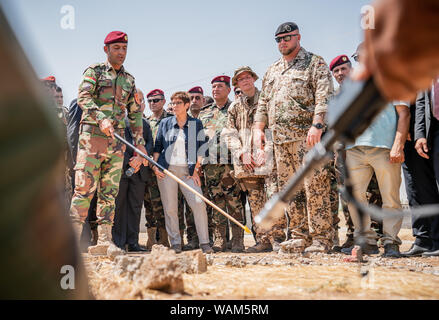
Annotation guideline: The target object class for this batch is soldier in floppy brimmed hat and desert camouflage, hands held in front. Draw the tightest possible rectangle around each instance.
[224,67,280,253]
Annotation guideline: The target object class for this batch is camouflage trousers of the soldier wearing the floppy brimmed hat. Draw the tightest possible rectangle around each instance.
[241,178,274,243]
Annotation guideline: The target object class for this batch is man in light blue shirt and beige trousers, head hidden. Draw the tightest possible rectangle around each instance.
[342,102,410,258]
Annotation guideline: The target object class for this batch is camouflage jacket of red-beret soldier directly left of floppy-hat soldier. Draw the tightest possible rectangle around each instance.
[198,100,232,164]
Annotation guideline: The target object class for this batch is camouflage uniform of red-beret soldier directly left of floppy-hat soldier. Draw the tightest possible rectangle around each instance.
[199,100,244,249]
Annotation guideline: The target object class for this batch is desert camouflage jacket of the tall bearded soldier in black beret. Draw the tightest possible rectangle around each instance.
[255,48,334,144]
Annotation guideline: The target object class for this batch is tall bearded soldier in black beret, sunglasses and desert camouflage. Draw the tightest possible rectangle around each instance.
[254,22,334,252]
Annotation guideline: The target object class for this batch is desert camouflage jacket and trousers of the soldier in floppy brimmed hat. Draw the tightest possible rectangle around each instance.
[224,89,273,243]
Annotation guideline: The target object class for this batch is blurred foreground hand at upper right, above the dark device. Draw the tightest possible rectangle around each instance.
[354,0,439,101]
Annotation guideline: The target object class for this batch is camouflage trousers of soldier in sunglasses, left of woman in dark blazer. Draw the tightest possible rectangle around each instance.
[143,168,165,228]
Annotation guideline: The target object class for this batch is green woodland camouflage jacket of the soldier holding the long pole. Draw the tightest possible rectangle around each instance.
[78,61,145,145]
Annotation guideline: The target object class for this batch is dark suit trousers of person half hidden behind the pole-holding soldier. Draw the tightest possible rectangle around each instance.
[112,173,145,248]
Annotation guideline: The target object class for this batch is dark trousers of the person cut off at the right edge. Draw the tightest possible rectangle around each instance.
[402,136,439,250]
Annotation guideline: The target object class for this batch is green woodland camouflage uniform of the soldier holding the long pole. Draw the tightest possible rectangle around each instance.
[70,62,145,224]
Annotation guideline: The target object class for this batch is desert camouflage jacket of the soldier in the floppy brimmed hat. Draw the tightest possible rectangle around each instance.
[224,89,273,178]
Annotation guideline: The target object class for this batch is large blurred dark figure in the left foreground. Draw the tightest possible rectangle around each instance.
[0,9,90,299]
